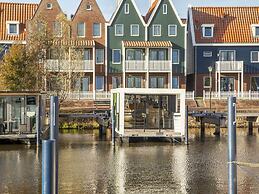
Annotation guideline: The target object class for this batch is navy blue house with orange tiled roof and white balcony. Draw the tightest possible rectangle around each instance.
[187,7,259,96]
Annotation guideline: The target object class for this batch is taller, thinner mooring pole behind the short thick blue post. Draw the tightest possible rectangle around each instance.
[50,96,59,194]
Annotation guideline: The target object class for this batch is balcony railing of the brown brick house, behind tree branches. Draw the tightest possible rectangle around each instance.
[46,59,94,72]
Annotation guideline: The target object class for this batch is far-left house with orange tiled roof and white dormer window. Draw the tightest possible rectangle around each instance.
[0,2,38,60]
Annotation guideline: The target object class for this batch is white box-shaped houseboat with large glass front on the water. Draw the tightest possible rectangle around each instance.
[111,88,185,138]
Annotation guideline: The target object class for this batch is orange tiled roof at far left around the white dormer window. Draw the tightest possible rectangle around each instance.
[0,2,38,41]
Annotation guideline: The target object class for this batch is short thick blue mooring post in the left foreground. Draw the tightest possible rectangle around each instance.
[42,140,56,194]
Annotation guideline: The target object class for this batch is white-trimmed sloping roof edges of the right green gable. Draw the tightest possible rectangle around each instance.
[145,0,185,26]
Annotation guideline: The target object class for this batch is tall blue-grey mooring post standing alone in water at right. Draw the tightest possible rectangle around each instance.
[228,96,237,194]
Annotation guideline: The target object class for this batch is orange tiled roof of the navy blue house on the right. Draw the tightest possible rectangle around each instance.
[191,7,259,43]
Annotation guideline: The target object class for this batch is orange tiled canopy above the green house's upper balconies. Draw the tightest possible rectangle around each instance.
[123,41,173,48]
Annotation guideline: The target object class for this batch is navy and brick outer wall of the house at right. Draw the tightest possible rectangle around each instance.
[187,46,259,96]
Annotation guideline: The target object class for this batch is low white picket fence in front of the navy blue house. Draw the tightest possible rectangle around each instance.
[203,90,259,100]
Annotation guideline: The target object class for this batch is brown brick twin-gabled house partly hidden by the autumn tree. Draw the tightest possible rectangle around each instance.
[31,0,107,99]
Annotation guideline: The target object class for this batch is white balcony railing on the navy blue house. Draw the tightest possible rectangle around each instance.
[216,61,244,72]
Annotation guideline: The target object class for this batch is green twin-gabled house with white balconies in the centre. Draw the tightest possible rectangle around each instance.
[107,0,186,90]
